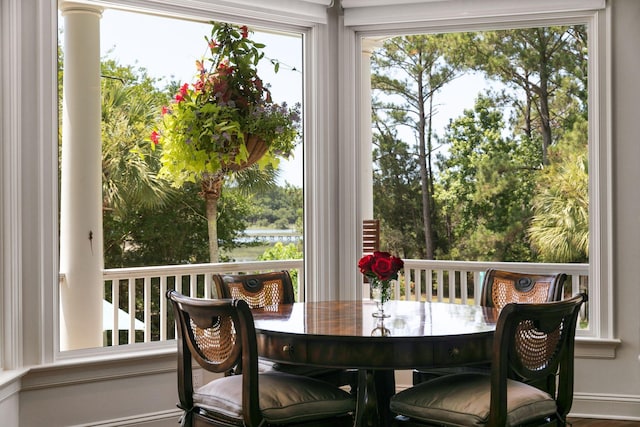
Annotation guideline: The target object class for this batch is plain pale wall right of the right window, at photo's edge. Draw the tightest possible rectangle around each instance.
[573,0,640,420]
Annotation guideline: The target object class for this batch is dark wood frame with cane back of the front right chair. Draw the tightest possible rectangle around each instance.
[397,294,587,427]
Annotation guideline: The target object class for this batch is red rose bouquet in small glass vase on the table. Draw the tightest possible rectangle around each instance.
[358,251,404,317]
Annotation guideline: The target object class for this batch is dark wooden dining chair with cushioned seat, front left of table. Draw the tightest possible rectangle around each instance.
[167,290,355,427]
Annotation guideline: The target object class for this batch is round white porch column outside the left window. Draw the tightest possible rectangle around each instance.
[60,1,104,350]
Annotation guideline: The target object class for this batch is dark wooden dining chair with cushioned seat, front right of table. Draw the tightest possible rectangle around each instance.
[389,294,587,427]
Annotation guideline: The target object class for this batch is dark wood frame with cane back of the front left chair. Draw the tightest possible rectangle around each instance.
[166,290,353,427]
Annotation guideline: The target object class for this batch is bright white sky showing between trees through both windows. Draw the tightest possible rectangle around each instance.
[69,9,486,187]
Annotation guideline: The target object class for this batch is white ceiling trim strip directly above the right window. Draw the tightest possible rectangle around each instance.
[341,0,606,26]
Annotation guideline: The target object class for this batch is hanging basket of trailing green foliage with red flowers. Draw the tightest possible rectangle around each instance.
[150,22,300,187]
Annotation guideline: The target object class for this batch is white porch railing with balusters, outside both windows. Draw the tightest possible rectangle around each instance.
[92,259,589,346]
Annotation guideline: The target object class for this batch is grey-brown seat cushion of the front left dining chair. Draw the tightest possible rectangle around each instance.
[193,371,355,424]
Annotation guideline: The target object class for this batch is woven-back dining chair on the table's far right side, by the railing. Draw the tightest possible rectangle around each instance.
[413,268,567,385]
